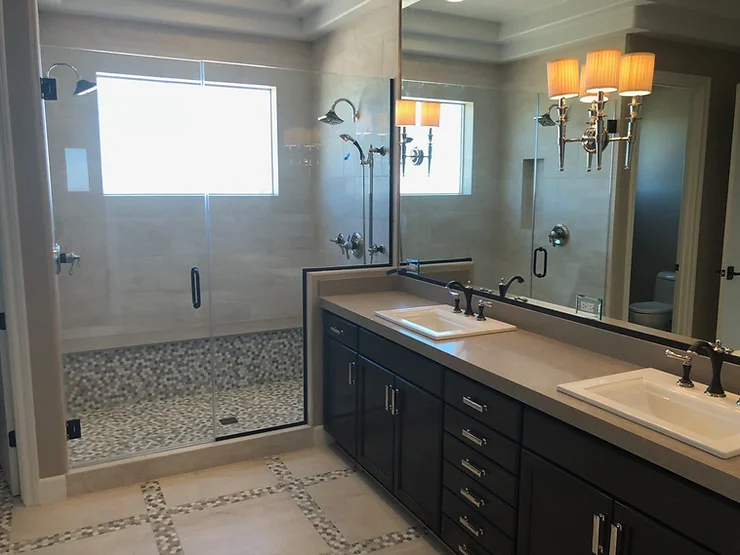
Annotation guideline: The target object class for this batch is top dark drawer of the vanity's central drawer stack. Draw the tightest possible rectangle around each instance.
[445,370,522,441]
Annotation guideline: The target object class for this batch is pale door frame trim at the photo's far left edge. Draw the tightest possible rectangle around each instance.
[0,0,39,505]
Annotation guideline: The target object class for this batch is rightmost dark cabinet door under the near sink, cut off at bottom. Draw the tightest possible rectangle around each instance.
[608,503,711,555]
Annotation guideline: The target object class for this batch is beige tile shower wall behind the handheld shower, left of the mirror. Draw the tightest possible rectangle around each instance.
[314,0,400,266]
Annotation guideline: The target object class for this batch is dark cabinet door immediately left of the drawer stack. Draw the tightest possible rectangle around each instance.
[393,377,444,534]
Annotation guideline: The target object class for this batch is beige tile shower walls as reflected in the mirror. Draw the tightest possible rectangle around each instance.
[401,35,625,307]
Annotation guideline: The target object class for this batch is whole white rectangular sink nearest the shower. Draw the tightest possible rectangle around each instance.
[375,305,516,341]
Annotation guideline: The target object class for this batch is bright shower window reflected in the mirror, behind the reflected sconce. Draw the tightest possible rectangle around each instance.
[401,102,469,195]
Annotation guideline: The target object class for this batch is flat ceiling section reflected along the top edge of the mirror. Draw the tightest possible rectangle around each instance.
[404,0,567,22]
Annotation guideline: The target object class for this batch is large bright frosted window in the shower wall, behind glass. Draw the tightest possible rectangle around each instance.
[97,75,278,195]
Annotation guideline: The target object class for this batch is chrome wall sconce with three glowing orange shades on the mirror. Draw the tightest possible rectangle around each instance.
[547,50,655,171]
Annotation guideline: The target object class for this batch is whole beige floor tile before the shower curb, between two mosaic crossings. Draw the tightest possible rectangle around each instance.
[159,460,277,507]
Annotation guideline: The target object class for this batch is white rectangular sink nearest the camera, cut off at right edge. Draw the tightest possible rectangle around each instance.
[558,368,740,459]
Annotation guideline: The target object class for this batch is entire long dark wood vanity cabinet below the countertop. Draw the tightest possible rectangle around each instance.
[324,313,740,555]
